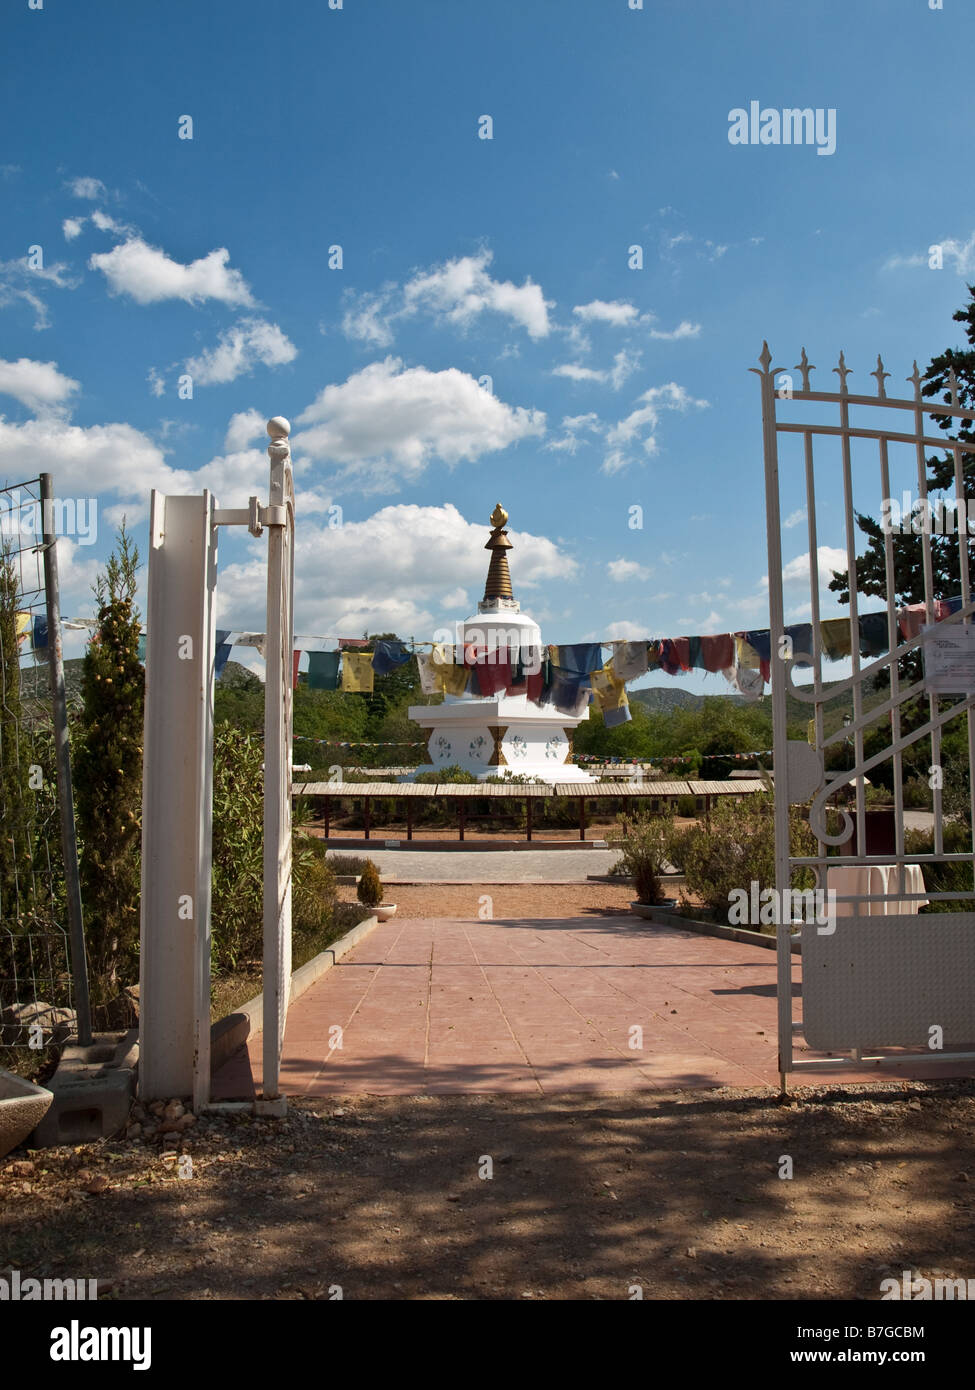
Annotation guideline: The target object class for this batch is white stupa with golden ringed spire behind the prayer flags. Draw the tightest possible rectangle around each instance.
[408,503,595,783]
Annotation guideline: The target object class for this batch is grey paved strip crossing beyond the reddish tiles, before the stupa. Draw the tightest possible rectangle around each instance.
[334,848,619,883]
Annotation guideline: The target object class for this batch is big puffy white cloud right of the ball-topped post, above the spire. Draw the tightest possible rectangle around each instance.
[293,357,545,488]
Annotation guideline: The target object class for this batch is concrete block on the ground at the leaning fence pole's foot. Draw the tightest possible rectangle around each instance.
[31,1029,139,1148]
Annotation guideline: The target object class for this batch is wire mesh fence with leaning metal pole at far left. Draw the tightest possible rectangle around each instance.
[0,477,88,1048]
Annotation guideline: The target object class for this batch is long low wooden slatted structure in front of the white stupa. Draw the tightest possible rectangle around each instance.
[292,778,766,841]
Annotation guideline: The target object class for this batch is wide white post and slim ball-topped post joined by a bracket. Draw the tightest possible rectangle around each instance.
[139,417,295,1109]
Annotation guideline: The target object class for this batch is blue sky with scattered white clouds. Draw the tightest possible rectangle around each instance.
[0,0,975,689]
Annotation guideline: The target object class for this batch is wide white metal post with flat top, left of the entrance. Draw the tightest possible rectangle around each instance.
[139,489,217,1108]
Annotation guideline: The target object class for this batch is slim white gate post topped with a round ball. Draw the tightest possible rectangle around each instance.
[263,416,295,1101]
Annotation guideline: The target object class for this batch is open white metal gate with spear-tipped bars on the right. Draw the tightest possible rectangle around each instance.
[751,343,975,1088]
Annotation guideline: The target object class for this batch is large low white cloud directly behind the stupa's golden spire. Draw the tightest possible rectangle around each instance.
[218,503,576,638]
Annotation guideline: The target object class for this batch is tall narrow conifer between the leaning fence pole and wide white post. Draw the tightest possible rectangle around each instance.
[74,521,145,1027]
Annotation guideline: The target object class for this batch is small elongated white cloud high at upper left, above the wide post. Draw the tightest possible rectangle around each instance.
[88,236,255,306]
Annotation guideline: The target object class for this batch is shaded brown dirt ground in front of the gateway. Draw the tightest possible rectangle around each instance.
[0,1083,975,1300]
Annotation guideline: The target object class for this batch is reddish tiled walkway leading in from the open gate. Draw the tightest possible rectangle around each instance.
[208,917,968,1098]
